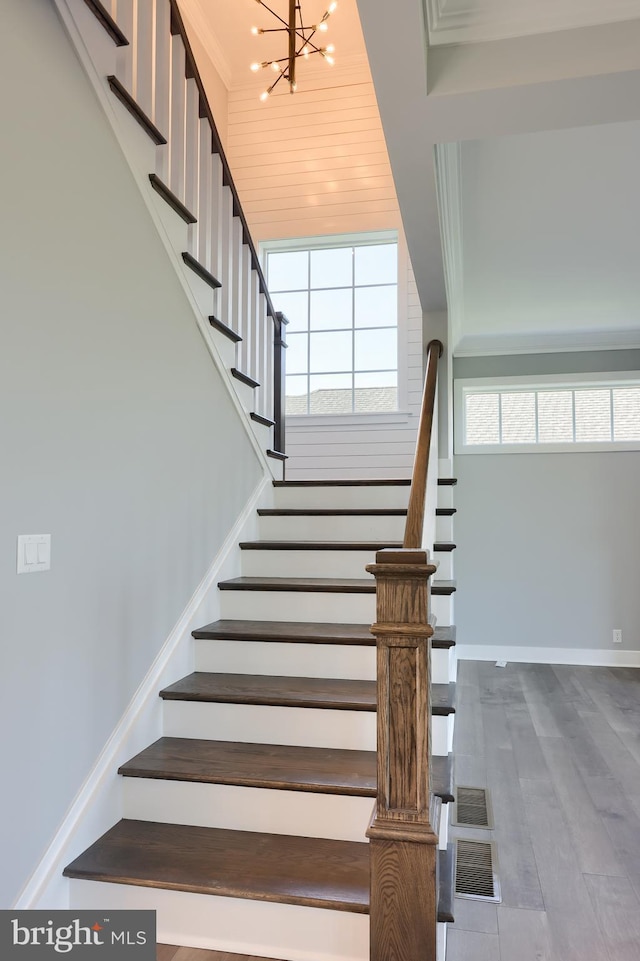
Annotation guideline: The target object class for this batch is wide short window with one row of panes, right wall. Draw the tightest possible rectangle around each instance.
[456,374,640,453]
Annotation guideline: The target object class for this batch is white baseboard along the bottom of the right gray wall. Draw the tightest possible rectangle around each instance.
[456,644,640,667]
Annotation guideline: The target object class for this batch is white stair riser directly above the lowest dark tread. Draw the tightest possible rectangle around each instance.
[123,777,375,841]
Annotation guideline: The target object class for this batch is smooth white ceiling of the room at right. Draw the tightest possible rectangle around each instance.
[457,122,640,353]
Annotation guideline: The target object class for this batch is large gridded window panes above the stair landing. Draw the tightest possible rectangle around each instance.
[267,233,398,414]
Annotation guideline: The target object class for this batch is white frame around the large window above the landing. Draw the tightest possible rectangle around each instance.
[259,229,411,418]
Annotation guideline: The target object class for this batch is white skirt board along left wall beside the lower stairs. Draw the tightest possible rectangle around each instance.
[13,475,271,910]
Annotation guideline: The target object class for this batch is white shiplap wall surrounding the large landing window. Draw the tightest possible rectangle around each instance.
[227,60,423,480]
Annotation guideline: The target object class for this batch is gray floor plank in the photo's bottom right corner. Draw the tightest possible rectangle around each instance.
[585,875,640,961]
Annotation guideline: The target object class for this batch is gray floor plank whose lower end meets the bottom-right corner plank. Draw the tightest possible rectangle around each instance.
[541,738,625,877]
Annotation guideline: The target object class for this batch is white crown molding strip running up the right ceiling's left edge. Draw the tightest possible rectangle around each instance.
[434,141,464,344]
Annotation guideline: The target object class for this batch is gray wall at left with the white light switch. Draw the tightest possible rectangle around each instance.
[0,0,261,907]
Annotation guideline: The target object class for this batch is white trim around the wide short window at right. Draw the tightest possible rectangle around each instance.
[453,370,640,455]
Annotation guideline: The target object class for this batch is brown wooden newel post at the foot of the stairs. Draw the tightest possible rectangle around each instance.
[367,549,438,961]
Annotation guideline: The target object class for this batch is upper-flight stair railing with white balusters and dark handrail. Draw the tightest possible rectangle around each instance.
[75,0,286,451]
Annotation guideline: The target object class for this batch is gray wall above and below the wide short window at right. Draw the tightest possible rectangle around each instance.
[454,351,640,650]
